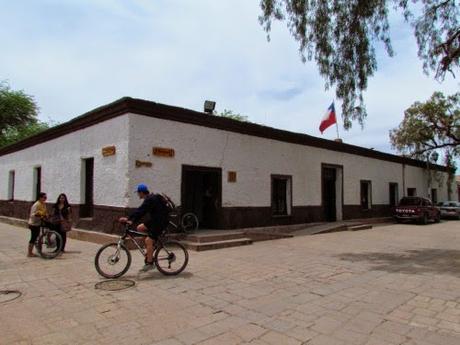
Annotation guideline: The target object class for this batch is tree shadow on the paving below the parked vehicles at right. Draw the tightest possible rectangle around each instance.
[337,248,460,276]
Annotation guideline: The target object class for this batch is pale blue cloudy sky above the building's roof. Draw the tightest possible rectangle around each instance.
[0,0,459,153]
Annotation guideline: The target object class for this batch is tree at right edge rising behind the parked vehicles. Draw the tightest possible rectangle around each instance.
[390,92,460,196]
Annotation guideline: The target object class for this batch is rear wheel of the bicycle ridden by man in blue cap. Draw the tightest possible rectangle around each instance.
[153,241,188,276]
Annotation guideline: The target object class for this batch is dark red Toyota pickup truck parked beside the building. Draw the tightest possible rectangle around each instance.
[394,196,441,224]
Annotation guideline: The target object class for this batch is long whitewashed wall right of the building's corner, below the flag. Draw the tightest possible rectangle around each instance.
[129,115,456,207]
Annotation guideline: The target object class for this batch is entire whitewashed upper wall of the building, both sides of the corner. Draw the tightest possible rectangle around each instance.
[0,114,447,207]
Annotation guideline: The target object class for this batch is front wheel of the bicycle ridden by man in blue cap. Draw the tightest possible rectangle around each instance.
[94,243,131,279]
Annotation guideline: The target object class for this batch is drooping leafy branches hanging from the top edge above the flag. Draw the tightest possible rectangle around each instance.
[259,0,460,129]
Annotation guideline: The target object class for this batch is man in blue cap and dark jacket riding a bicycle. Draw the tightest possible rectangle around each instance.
[119,183,169,272]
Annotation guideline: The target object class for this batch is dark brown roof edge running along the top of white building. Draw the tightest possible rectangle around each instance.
[0,97,448,172]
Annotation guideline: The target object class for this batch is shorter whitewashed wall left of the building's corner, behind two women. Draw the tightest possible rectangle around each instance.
[0,115,129,207]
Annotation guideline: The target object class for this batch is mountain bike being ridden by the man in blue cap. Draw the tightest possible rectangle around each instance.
[94,224,188,279]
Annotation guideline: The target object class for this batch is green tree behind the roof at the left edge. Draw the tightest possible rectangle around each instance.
[0,82,52,147]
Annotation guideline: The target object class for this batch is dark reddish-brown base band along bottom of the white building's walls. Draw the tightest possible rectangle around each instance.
[0,200,391,234]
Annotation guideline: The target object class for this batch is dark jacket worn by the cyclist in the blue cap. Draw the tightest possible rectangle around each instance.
[129,194,169,231]
